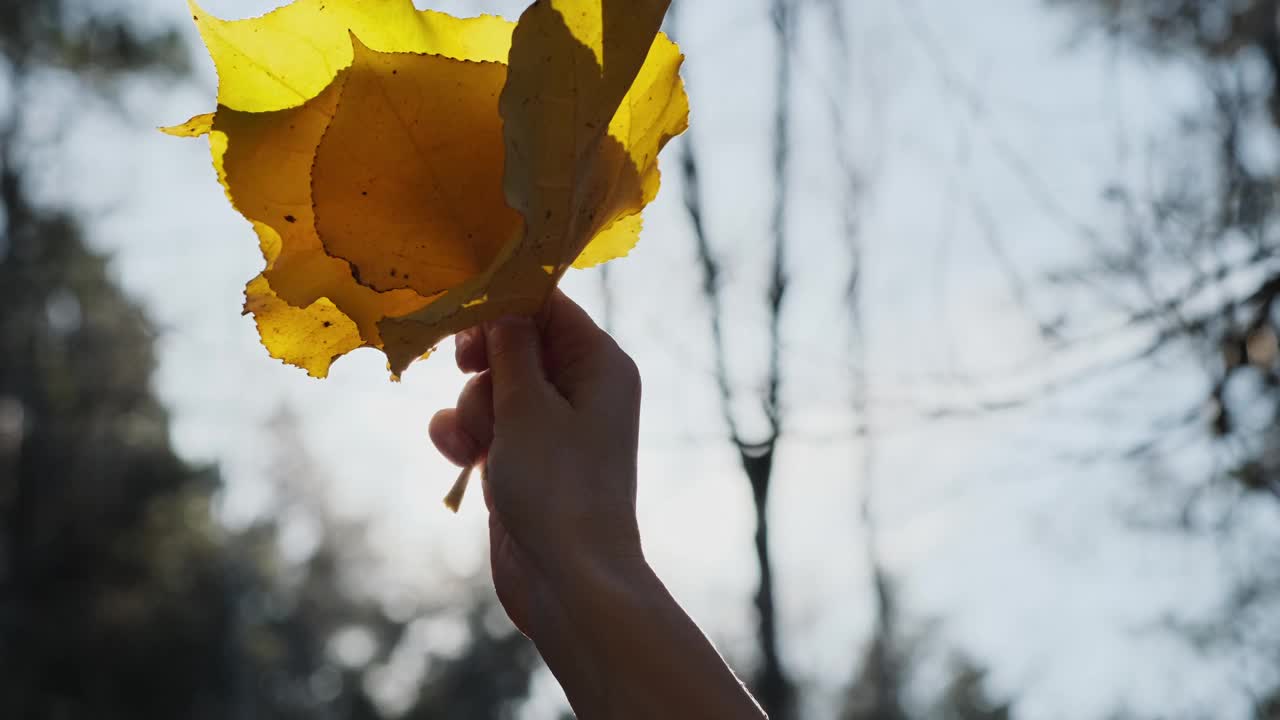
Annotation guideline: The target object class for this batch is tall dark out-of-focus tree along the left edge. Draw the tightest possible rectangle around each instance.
[0,3,230,719]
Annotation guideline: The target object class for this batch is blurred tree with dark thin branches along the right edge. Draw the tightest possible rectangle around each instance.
[1050,0,1280,500]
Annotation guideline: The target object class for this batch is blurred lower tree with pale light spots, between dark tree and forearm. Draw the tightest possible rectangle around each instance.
[254,411,539,720]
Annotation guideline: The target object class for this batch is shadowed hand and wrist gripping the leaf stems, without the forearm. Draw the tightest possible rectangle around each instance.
[430,291,644,639]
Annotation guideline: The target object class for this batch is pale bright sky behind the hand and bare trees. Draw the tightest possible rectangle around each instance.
[37,0,1275,720]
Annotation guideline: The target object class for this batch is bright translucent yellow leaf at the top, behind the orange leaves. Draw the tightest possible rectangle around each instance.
[188,0,512,113]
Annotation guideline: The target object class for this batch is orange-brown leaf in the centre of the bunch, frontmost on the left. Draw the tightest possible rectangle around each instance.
[311,35,522,296]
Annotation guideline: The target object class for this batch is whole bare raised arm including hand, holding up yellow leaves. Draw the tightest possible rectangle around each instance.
[431,288,764,720]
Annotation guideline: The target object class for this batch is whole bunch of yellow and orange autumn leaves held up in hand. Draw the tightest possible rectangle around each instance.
[166,0,689,377]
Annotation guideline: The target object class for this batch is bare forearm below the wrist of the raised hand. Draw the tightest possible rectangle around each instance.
[532,550,764,720]
